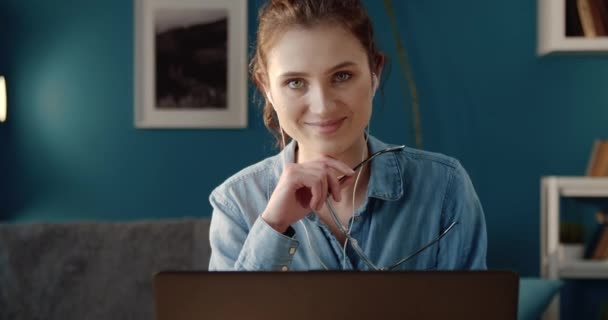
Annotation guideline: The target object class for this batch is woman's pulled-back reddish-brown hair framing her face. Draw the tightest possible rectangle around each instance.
[249,0,383,148]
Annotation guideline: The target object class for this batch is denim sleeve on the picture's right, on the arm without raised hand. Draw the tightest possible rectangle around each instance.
[438,162,487,270]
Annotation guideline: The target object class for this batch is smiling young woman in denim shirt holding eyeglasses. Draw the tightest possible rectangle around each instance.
[209,0,487,271]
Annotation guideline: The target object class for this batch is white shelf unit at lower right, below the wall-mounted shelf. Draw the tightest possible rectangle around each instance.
[540,176,608,320]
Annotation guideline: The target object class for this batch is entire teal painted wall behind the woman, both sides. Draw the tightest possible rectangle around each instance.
[0,0,608,275]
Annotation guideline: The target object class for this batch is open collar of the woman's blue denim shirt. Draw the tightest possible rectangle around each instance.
[275,135,404,200]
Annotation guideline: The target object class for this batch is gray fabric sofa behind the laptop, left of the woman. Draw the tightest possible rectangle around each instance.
[0,219,210,320]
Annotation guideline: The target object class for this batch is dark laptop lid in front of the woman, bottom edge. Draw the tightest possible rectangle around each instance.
[154,271,519,320]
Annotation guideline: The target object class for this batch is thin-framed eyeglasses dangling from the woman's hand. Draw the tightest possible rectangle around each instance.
[325,146,458,271]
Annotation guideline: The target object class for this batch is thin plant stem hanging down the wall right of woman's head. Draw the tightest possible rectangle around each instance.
[383,0,422,149]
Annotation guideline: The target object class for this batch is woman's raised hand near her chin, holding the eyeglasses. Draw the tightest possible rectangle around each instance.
[262,156,355,233]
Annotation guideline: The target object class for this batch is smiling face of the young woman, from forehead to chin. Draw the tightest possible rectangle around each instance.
[266,25,373,156]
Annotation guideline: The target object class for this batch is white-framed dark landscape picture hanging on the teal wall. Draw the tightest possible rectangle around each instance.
[134,0,248,129]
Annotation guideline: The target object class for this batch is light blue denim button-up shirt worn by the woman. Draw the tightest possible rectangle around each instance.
[209,136,487,271]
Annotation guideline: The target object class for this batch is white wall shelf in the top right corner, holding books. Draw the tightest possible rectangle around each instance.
[537,0,608,56]
